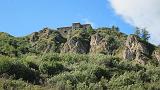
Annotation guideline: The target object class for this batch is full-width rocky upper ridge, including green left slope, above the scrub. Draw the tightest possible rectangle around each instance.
[0,28,160,64]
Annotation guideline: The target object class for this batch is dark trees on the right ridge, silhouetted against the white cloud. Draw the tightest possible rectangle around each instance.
[134,27,150,41]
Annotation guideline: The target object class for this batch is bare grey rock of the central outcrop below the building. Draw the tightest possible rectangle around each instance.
[61,37,89,54]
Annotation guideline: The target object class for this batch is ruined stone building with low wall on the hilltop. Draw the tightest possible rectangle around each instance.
[57,23,92,37]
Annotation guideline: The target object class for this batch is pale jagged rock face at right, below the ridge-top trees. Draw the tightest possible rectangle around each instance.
[123,35,149,63]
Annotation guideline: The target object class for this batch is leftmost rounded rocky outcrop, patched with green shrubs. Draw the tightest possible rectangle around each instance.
[29,28,64,53]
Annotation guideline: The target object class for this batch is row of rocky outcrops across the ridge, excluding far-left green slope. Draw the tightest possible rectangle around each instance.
[29,28,160,64]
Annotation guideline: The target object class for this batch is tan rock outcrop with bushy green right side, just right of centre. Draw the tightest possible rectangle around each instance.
[90,28,126,55]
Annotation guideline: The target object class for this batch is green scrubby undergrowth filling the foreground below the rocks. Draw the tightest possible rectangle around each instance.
[0,53,160,90]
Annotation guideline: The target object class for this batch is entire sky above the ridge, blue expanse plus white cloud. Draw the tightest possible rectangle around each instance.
[0,0,160,44]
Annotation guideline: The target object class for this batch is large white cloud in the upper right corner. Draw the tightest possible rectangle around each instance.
[109,0,160,44]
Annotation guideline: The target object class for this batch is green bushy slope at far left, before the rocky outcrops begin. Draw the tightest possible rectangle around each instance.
[0,32,29,56]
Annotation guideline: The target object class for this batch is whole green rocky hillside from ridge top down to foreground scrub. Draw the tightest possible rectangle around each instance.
[0,23,160,90]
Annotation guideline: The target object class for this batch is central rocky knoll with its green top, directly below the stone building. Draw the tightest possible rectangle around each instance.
[61,30,90,54]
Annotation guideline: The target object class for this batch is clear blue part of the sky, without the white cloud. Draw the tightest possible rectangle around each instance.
[0,0,134,36]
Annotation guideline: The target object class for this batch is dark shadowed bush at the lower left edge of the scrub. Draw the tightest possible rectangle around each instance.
[0,58,40,83]
